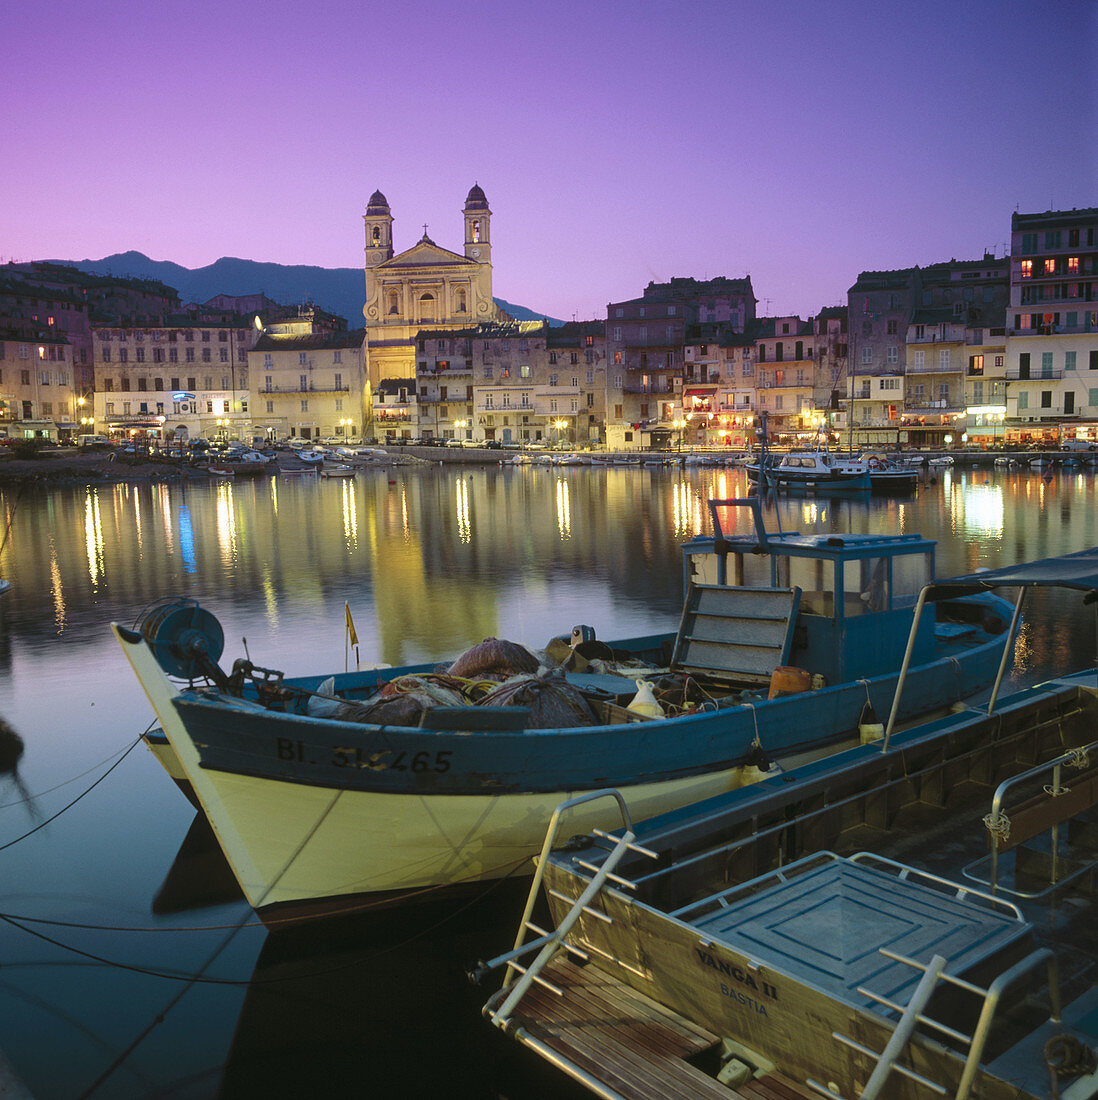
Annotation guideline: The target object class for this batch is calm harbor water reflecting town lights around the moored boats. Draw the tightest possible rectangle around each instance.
[0,465,1098,1100]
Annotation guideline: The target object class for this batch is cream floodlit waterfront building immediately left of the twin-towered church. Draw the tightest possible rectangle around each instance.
[249,307,373,441]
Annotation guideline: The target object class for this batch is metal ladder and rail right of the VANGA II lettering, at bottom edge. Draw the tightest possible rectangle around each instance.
[822,947,1061,1100]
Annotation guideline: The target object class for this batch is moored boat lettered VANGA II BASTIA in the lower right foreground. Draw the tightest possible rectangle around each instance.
[484,548,1098,1100]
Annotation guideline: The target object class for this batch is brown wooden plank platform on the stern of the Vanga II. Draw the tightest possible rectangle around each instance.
[507,957,819,1100]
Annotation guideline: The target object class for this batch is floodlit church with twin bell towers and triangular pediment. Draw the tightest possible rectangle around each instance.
[362,184,510,389]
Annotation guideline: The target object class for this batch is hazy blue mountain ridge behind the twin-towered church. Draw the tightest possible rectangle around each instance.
[50,252,563,329]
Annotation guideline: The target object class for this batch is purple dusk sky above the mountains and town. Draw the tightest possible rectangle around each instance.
[0,0,1098,319]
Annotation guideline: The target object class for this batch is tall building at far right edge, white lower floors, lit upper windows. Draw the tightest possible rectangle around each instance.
[1006,208,1098,447]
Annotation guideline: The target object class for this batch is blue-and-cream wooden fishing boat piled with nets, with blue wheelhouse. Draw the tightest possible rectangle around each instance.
[113,499,1013,915]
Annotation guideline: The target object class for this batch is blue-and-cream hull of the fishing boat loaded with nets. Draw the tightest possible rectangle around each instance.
[114,598,1003,914]
